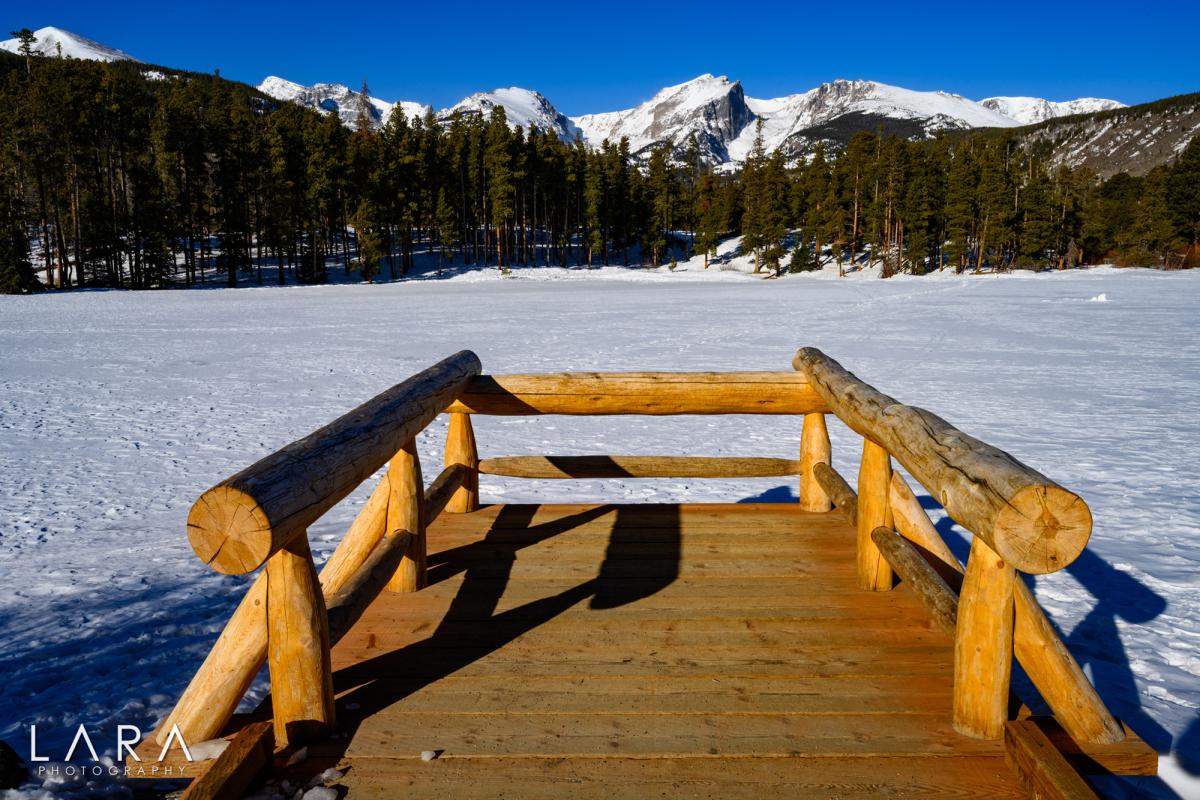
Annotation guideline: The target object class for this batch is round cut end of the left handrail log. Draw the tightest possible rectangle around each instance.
[187,485,272,575]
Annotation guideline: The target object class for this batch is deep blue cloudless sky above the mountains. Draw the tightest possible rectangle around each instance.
[0,0,1200,114]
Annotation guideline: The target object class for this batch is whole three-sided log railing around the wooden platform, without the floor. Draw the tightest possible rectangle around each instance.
[164,349,1123,762]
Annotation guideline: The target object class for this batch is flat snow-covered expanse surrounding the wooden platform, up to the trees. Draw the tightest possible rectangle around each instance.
[0,265,1200,796]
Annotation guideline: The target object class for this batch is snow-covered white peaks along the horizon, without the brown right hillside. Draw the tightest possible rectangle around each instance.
[0,28,1142,168]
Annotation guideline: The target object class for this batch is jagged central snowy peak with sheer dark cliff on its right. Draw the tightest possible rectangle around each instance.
[571,74,755,163]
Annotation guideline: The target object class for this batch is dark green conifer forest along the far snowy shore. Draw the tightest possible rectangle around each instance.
[0,38,1200,291]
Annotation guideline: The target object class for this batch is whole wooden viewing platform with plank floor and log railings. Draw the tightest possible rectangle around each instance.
[142,349,1157,799]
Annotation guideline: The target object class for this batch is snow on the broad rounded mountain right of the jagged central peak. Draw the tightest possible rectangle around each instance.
[730,80,1018,161]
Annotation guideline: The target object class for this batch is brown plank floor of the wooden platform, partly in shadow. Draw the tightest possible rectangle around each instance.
[285,505,1025,798]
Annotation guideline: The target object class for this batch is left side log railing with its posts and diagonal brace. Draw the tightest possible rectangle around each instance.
[157,350,480,744]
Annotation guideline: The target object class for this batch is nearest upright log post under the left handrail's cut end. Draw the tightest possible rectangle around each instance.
[266,535,335,745]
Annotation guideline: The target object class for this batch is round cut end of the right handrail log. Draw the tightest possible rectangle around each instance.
[992,483,1092,575]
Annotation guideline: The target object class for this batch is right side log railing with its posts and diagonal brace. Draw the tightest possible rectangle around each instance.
[793,348,1124,744]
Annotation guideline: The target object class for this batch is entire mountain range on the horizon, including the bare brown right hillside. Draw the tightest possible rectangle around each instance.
[9,28,1161,175]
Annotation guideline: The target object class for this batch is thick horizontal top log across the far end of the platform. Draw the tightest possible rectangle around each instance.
[446,372,828,416]
